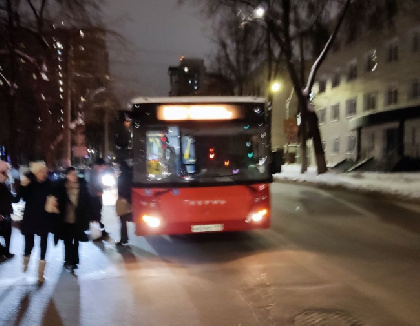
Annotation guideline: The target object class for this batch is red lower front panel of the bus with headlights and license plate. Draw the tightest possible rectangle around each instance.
[132,184,270,235]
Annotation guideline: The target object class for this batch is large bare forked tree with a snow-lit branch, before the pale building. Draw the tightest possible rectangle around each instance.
[181,0,351,173]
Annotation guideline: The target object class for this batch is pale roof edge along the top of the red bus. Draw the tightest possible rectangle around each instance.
[129,96,266,106]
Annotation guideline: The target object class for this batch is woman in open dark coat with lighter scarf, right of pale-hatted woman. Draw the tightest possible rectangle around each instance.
[54,167,90,270]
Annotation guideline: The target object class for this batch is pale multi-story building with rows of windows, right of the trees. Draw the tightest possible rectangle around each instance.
[313,1,420,169]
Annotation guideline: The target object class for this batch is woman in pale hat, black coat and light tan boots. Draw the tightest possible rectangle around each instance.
[20,161,52,283]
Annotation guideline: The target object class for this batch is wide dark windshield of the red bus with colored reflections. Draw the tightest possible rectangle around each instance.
[133,124,271,186]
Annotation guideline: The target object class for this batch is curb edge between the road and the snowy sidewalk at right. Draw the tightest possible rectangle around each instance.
[273,177,420,204]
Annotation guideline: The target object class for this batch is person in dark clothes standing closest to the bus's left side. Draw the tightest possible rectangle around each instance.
[115,160,132,246]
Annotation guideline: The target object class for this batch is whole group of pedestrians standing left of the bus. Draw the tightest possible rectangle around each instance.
[0,159,131,283]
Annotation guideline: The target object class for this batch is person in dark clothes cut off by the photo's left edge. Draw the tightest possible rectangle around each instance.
[0,160,19,259]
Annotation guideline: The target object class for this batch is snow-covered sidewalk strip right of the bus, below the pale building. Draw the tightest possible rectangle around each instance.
[273,164,420,200]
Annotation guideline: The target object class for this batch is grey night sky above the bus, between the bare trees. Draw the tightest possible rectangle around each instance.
[104,0,213,100]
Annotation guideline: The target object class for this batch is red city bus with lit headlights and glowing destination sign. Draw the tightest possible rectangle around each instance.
[124,96,272,235]
